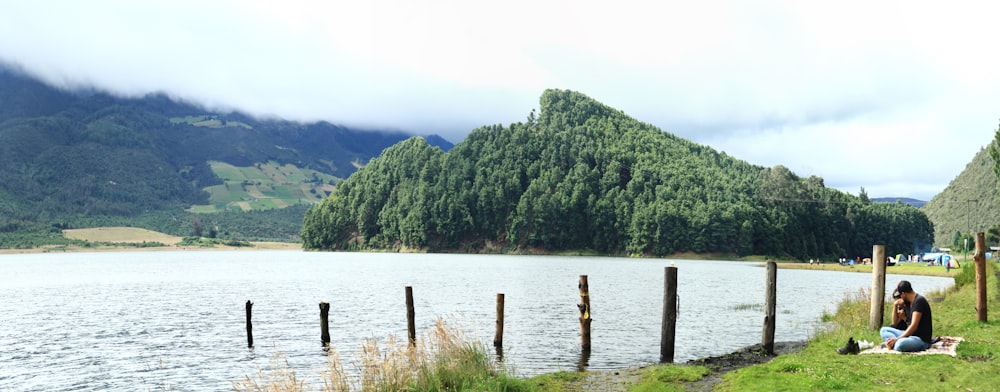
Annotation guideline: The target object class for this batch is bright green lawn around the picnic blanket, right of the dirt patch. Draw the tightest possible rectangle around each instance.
[716,263,1000,391]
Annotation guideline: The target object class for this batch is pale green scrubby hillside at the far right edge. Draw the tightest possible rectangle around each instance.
[923,138,1000,249]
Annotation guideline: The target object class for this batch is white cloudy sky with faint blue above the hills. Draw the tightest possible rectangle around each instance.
[0,0,1000,200]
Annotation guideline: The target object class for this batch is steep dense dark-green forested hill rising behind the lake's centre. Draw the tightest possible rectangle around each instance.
[302,90,933,260]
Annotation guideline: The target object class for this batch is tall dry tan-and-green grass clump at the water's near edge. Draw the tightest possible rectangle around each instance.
[233,319,531,392]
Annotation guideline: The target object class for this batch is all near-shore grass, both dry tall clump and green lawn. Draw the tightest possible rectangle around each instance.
[234,263,1000,392]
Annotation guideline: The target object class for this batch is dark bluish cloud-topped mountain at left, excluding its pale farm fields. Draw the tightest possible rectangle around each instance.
[0,64,451,244]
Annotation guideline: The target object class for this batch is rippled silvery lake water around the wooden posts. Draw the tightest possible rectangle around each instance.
[0,251,953,391]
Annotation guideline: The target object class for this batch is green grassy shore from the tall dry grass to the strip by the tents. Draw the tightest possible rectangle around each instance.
[529,262,1000,392]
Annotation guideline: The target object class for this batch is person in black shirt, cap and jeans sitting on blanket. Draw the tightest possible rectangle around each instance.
[879,280,934,352]
